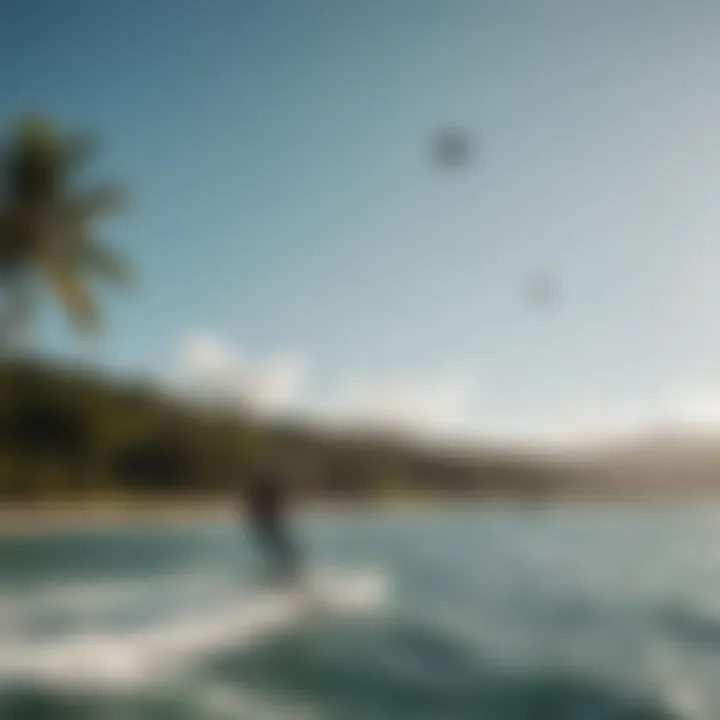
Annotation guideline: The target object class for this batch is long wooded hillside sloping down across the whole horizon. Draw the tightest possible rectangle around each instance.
[0,362,720,502]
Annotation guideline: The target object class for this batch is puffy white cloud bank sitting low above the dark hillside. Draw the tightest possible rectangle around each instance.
[174,332,477,437]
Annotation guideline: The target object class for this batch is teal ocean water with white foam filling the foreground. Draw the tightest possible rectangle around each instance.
[0,505,720,720]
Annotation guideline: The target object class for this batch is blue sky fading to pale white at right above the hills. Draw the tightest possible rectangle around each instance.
[0,0,720,444]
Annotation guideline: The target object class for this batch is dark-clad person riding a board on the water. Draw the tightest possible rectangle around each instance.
[247,469,299,582]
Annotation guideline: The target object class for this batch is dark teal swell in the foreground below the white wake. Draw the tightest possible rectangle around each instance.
[204,619,695,720]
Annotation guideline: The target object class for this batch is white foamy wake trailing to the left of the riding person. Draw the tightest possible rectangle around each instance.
[0,572,387,688]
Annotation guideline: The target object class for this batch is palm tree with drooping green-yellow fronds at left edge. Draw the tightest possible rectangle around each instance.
[0,119,130,351]
